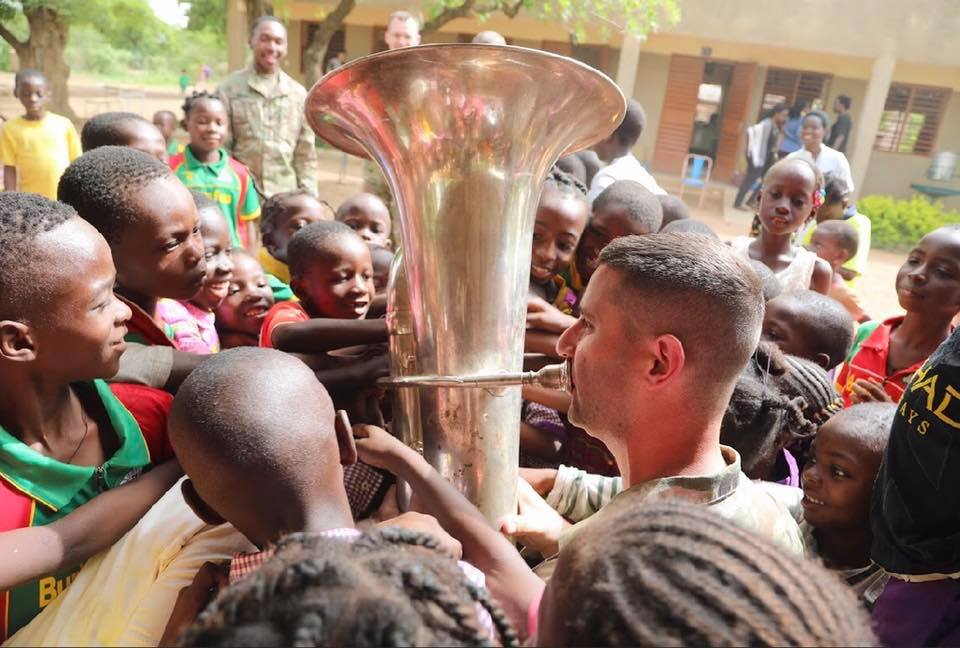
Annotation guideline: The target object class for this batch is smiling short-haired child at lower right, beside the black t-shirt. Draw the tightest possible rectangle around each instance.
[800,403,892,614]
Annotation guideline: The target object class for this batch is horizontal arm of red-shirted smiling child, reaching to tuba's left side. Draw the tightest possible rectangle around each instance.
[270,317,387,353]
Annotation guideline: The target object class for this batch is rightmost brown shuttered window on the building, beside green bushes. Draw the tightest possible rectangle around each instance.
[873,83,950,155]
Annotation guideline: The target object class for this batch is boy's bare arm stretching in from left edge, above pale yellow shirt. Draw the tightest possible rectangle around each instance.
[0,461,183,590]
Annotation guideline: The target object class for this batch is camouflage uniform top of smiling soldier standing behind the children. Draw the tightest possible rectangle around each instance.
[218,68,317,197]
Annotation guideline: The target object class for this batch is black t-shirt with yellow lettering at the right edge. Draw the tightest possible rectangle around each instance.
[870,328,960,574]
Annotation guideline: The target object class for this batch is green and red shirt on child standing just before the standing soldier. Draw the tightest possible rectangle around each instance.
[170,146,260,247]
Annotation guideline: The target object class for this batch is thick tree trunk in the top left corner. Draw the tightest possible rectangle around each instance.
[4,7,77,121]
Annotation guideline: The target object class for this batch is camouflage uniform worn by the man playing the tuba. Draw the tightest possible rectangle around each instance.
[547,446,803,557]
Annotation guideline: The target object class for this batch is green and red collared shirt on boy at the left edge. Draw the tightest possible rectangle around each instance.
[0,380,173,641]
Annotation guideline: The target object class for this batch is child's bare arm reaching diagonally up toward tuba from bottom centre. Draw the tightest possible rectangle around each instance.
[353,425,544,635]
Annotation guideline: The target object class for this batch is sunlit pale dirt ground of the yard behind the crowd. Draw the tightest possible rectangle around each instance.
[0,72,904,318]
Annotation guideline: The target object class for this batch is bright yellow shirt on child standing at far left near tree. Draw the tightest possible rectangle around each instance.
[0,113,81,200]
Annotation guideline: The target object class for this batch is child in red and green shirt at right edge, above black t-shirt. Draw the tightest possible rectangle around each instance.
[837,225,960,405]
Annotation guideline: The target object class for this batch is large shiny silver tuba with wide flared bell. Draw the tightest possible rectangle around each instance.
[306,44,625,521]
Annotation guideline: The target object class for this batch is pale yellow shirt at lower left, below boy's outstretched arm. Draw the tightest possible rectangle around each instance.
[4,483,256,646]
